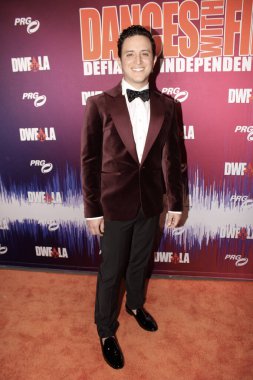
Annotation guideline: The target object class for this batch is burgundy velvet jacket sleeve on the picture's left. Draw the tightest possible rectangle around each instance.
[81,97,103,218]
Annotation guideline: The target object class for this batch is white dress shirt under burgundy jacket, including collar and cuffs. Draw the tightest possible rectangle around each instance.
[86,78,182,220]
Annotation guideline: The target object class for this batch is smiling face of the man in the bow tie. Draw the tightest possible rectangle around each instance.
[119,35,156,89]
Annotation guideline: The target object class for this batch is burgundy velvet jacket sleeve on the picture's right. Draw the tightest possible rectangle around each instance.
[163,100,183,211]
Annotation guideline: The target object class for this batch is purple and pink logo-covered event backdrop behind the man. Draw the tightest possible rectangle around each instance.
[0,0,253,279]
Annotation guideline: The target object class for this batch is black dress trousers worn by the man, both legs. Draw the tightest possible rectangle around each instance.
[95,210,159,338]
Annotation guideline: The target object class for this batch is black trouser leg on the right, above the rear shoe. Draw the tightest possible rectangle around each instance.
[126,209,159,309]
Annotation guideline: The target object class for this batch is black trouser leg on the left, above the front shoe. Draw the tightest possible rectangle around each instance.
[95,220,134,338]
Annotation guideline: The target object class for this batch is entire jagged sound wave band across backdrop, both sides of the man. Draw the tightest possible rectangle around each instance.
[0,166,253,263]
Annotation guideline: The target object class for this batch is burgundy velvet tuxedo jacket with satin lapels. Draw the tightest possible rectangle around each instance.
[81,83,182,220]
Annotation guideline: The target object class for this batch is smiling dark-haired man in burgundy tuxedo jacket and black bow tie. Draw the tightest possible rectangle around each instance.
[81,25,182,369]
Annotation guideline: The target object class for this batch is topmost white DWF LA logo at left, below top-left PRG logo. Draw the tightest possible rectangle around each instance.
[11,55,50,73]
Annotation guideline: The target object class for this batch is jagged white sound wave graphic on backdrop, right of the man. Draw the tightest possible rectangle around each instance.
[160,170,253,253]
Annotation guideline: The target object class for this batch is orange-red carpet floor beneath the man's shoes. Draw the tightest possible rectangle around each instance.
[0,269,253,380]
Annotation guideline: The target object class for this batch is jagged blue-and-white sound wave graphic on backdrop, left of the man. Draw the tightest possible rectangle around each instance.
[0,167,99,262]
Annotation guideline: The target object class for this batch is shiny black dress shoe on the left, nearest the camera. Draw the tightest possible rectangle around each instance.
[100,336,124,369]
